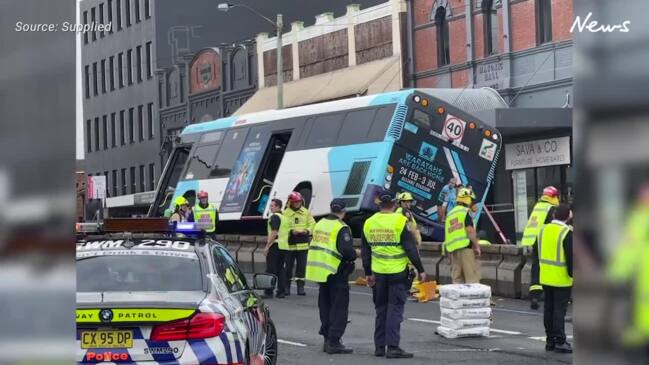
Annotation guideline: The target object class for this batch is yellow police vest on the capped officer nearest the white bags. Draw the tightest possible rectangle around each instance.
[363,212,408,274]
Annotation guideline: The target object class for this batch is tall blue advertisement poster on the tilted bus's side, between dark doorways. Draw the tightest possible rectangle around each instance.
[219,130,269,213]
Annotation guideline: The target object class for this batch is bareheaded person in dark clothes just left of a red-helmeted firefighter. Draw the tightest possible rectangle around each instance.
[264,199,288,298]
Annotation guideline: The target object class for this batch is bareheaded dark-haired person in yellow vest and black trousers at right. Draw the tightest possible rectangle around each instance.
[533,204,573,353]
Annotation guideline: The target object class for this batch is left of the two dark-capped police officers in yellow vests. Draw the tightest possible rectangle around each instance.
[306,199,356,354]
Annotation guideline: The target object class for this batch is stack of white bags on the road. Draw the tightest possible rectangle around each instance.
[437,284,491,338]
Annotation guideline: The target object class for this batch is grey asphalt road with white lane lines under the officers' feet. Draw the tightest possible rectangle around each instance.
[266,285,573,365]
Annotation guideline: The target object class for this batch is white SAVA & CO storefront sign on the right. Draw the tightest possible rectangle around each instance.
[505,137,570,170]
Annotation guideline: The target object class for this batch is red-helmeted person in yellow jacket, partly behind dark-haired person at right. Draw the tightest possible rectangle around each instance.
[521,186,559,310]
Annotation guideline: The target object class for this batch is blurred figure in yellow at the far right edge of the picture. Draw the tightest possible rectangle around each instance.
[608,184,649,348]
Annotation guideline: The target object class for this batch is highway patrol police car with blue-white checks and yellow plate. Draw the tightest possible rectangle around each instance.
[76,220,277,364]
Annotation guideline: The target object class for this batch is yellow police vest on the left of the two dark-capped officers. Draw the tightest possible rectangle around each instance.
[305,218,346,283]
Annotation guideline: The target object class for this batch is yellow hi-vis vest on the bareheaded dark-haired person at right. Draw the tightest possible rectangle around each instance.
[538,223,572,287]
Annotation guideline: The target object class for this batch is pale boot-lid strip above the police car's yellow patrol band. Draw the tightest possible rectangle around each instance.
[77,291,207,309]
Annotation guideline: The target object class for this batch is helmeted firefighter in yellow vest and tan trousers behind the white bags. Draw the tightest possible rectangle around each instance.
[444,188,480,284]
